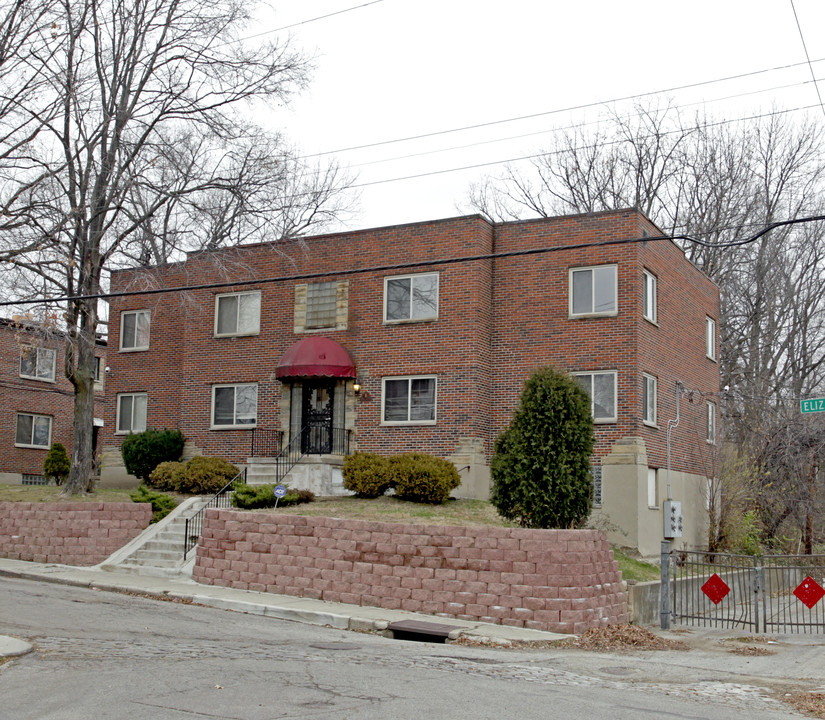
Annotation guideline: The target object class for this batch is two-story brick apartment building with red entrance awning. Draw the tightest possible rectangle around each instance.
[104,210,719,554]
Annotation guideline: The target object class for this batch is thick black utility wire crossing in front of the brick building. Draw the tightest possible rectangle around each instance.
[6,215,825,307]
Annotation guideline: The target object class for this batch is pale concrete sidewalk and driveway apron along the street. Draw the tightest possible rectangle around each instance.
[0,558,825,692]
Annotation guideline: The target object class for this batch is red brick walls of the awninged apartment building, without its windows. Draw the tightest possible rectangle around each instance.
[106,210,718,473]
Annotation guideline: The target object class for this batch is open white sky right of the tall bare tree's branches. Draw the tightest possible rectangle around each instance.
[266,0,825,229]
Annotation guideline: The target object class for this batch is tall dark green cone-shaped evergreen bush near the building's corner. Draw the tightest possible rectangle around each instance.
[490,367,593,528]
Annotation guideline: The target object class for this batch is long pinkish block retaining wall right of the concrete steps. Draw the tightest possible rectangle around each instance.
[193,510,628,633]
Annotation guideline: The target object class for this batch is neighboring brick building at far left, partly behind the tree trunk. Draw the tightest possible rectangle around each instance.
[0,319,106,484]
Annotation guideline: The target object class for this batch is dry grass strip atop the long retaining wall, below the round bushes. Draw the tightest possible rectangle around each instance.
[258,496,518,527]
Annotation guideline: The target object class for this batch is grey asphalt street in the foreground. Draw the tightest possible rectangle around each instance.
[0,577,825,720]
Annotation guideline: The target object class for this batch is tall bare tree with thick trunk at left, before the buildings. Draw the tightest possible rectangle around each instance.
[0,0,350,493]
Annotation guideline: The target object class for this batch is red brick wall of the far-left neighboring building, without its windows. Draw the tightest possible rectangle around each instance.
[0,321,106,475]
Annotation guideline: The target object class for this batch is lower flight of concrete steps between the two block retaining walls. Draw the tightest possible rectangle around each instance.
[99,497,211,577]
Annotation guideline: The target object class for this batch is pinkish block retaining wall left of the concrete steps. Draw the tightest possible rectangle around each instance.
[0,502,152,565]
